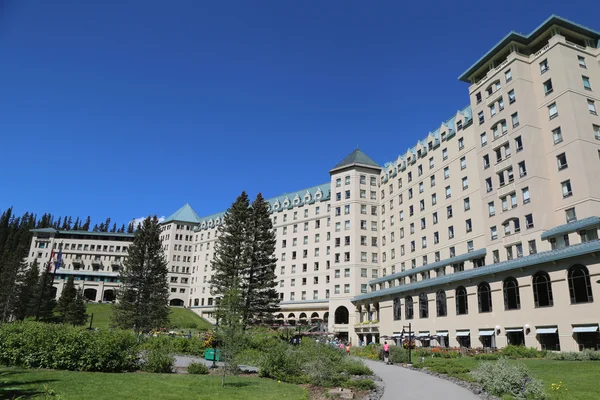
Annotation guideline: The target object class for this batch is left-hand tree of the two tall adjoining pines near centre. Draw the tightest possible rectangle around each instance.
[210,192,251,296]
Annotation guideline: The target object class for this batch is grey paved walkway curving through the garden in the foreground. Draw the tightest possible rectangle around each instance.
[363,360,479,400]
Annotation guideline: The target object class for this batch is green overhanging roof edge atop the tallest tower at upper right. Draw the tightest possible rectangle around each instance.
[458,15,600,83]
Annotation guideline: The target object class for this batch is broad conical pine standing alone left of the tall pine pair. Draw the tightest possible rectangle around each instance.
[113,216,169,332]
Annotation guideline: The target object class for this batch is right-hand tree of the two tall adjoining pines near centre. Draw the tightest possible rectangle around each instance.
[242,193,279,326]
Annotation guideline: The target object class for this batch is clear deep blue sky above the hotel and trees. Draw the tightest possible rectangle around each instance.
[0,0,600,223]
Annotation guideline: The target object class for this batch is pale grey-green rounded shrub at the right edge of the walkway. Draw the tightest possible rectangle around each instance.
[471,357,546,399]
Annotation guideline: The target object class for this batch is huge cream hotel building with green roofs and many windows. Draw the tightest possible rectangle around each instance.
[29,16,600,350]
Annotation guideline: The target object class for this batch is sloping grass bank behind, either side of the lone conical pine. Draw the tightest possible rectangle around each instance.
[87,303,212,330]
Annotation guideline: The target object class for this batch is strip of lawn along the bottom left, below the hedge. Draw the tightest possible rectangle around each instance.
[0,368,307,400]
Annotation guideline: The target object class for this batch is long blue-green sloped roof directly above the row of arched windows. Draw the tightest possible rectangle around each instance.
[352,240,600,302]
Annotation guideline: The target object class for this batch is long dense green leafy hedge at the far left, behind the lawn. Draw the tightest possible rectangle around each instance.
[0,322,139,372]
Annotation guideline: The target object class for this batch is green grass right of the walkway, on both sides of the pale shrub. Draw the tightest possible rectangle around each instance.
[414,357,600,400]
